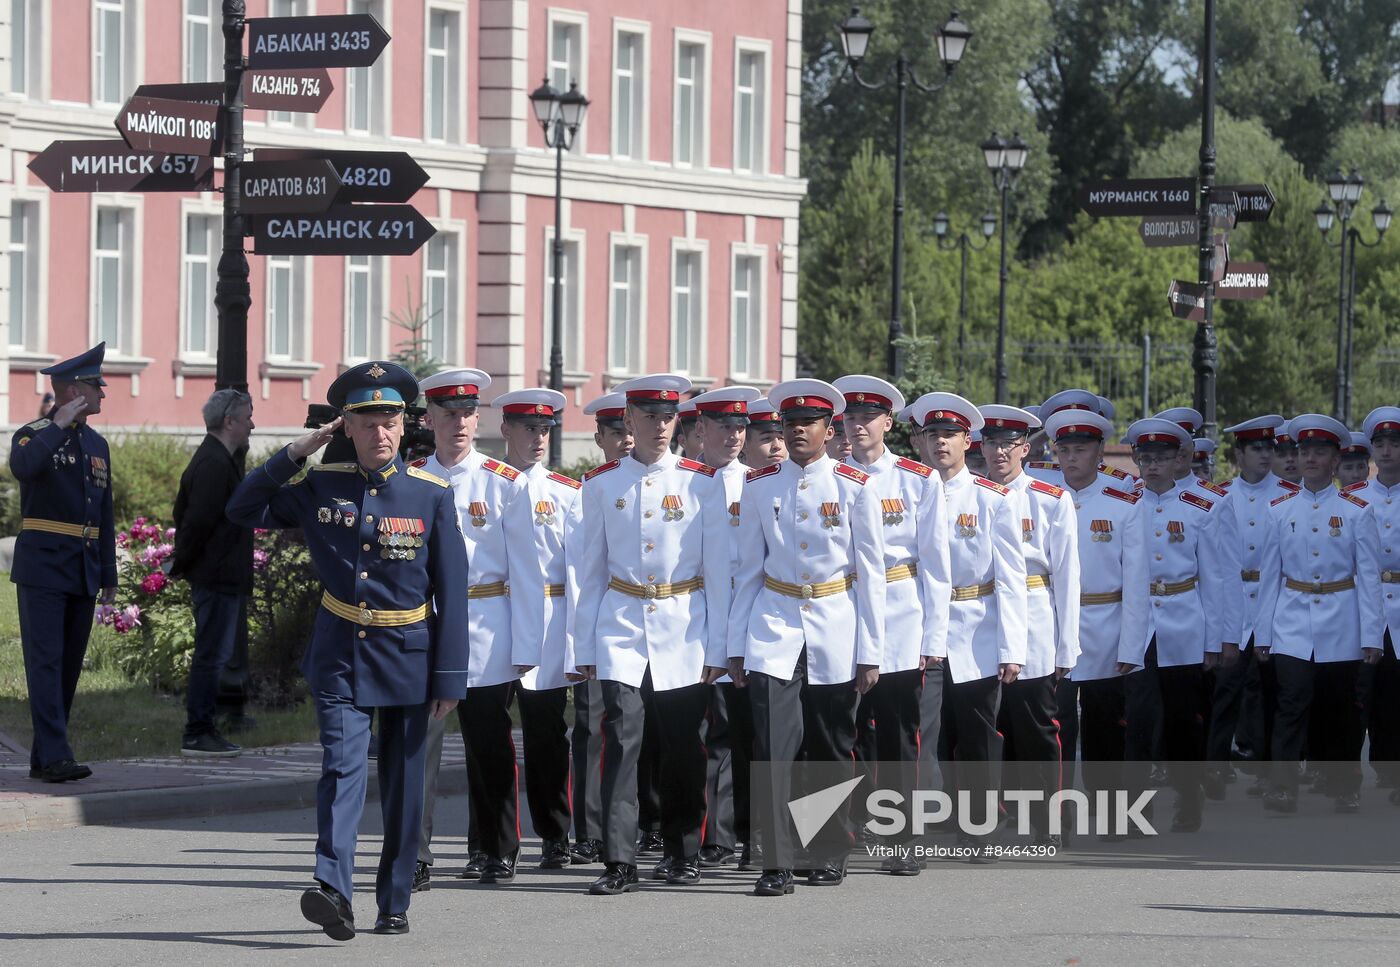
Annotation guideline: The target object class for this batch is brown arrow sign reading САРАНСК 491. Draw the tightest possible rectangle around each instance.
[252,204,437,255]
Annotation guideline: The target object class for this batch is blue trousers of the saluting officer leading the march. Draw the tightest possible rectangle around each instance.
[314,691,428,914]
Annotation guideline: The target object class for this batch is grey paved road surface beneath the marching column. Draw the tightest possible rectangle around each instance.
[0,786,1400,967]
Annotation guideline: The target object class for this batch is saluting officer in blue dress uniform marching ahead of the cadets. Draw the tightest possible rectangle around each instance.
[228,361,466,940]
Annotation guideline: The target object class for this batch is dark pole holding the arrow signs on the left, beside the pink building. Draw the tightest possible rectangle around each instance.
[214,0,252,392]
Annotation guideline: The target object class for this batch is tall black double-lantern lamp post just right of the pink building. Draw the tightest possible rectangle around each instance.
[841,7,972,381]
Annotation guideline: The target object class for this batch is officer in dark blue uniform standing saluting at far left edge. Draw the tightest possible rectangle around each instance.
[10,343,116,782]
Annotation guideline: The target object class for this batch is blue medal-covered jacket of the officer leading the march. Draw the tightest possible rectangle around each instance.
[227,449,468,707]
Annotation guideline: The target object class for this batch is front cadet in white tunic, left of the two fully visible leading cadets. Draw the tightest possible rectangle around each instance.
[574,374,731,894]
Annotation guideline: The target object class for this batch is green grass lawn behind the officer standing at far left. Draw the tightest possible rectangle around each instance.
[0,572,316,761]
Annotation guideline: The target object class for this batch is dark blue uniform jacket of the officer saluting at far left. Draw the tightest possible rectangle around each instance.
[10,420,116,598]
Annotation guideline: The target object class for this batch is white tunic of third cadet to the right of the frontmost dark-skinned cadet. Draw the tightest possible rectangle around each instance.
[1007,473,1079,679]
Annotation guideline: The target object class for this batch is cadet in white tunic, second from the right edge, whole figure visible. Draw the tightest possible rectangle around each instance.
[1254,413,1385,813]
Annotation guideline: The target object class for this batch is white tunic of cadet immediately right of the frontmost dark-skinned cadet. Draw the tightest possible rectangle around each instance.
[846,448,952,673]
